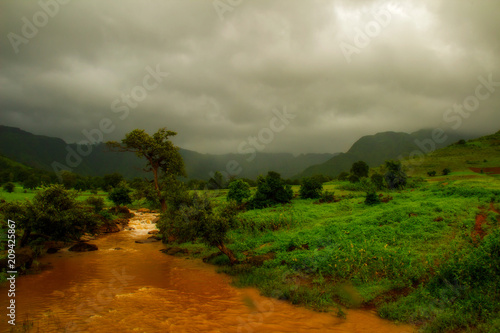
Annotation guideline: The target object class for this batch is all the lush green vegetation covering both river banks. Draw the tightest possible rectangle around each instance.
[0,126,500,332]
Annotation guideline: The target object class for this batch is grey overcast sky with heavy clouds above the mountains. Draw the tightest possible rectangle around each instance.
[0,0,500,153]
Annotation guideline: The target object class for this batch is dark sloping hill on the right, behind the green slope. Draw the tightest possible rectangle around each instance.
[293,129,471,179]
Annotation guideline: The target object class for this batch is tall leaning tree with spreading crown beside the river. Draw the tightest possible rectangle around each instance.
[106,128,185,212]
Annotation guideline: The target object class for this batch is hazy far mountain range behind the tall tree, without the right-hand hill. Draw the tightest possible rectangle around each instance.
[0,125,335,180]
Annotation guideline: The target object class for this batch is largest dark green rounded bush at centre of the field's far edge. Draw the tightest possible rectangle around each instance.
[249,171,293,209]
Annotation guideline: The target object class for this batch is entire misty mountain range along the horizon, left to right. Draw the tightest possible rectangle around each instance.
[0,125,471,180]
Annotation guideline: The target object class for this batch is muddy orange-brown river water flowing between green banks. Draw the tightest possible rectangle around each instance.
[0,213,413,333]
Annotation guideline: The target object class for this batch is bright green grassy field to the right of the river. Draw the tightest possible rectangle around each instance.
[173,172,500,332]
